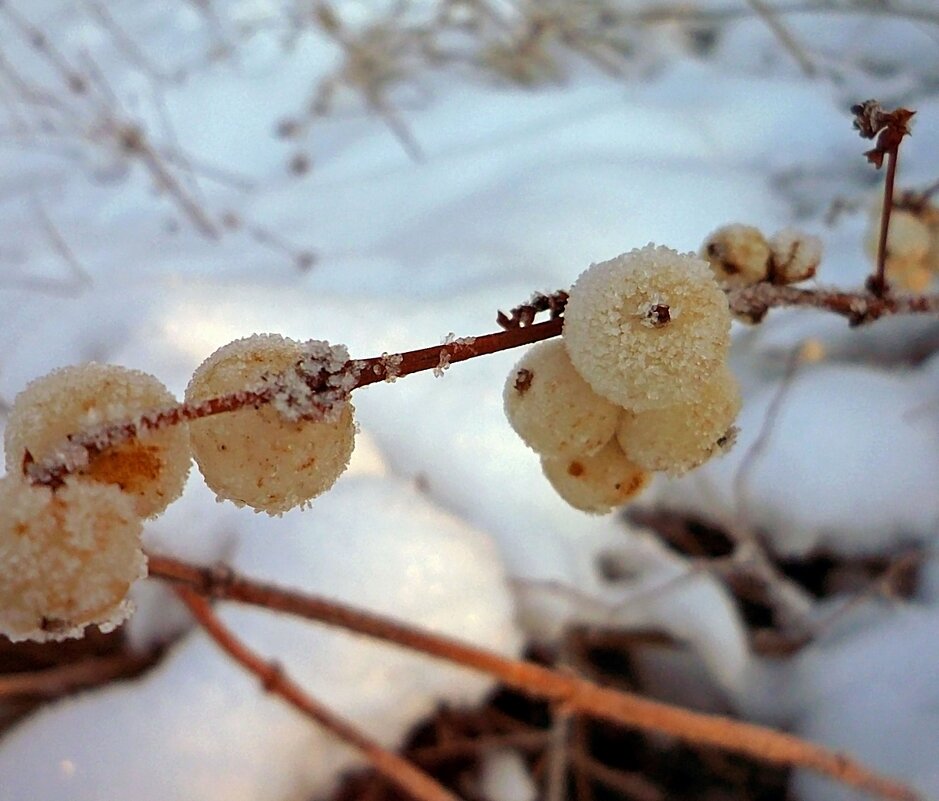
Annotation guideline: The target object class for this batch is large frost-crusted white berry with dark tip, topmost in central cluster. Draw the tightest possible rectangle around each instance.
[563,245,731,411]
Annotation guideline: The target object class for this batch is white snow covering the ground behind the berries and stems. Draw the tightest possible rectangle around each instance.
[0,0,939,801]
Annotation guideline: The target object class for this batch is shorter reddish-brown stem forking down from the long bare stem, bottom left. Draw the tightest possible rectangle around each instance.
[176,586,459,801]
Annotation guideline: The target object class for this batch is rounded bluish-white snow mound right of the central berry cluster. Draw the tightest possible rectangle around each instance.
[657,363,939,556]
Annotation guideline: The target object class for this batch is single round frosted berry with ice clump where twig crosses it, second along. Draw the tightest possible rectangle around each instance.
[186,334,355,514]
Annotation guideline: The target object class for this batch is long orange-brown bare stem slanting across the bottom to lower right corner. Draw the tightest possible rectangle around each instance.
[149,555,919,801]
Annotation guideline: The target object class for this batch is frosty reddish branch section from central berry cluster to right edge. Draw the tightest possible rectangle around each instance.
[727,283,939,326]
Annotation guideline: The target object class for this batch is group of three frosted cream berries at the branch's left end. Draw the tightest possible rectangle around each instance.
[0,335,355,640]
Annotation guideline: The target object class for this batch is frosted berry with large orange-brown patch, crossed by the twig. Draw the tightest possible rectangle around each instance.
[4,362,190,517]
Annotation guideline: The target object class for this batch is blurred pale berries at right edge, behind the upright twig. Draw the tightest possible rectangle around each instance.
[864,195,939,292]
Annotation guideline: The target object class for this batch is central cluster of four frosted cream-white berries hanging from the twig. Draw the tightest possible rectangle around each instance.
[504,245,740,514]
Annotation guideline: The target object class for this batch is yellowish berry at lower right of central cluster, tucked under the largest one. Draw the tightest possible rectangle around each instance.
[616,366,740,476]
